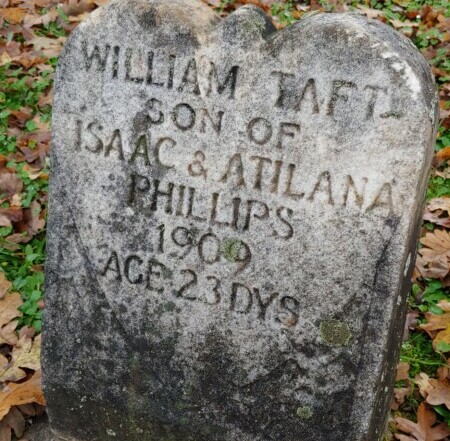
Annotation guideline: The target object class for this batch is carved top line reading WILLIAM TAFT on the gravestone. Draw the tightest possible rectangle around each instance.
[82,41,403,120]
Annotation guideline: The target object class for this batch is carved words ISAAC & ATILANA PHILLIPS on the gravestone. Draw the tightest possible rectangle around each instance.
[74,116,394,223]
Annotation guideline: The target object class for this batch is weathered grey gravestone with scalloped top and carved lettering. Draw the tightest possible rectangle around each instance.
[43,0,436,441]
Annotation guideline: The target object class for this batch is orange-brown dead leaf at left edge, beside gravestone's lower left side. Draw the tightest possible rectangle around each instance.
[0,369,45,420]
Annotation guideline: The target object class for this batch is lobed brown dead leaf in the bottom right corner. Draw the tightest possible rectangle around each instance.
[395,403,450,441]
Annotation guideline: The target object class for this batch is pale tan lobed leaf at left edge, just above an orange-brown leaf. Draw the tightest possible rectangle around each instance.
[0,334,41,382]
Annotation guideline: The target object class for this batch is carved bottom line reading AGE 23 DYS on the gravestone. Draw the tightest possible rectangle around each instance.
[100,248,300,327]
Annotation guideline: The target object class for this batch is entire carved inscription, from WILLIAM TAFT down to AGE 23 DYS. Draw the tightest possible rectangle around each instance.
[78,43,401,327]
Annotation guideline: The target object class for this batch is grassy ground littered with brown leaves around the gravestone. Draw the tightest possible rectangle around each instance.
[0,0,450,441]
